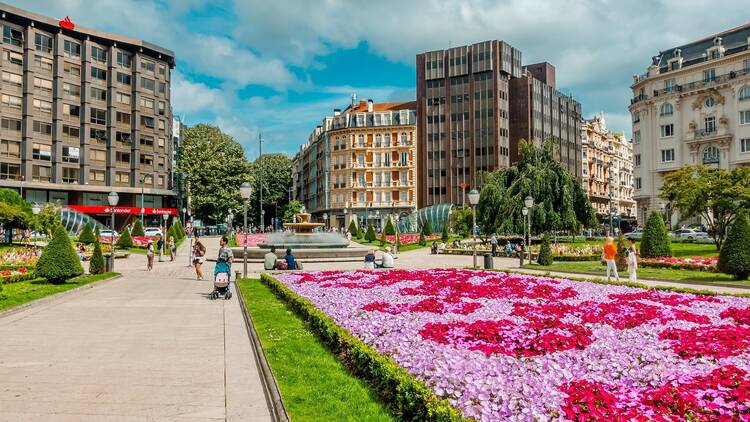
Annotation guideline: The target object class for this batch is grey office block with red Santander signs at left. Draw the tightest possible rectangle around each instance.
[0,3,176,224]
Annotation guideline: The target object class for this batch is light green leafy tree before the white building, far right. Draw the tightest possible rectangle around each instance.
[661,165,750,250]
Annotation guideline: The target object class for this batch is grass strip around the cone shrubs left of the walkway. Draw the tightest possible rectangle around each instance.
[0,273,117,311]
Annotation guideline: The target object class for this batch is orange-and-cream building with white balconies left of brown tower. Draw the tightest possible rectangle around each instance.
[292,96,417,231]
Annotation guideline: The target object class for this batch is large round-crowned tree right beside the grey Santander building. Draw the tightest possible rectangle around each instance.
[178,124,252,223]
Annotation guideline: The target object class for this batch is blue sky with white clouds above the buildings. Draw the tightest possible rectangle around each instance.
[13,0,747,158]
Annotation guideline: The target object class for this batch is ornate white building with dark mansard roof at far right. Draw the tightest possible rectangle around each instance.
[629,24,750,227]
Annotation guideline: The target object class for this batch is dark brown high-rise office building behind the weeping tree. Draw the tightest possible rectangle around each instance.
[416,40,581,208]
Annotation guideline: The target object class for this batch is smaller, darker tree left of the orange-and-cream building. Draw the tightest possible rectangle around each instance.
[248,154,292,224]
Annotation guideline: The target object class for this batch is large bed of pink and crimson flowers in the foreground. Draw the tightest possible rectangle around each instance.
[279,269,750,421]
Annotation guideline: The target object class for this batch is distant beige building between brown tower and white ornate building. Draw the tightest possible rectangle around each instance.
[581,116,636,218]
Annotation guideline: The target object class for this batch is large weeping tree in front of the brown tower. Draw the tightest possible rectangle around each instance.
[477,140,596,234]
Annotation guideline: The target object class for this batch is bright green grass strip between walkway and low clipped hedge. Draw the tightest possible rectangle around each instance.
[238,280,395,422]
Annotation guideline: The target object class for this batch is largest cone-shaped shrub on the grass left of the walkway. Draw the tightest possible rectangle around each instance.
[36,226,83,283]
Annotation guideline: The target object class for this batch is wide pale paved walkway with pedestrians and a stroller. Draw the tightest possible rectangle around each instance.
[0,239,270,421]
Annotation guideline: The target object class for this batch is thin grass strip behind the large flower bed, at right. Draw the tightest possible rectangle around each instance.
[523,261,750,285]
